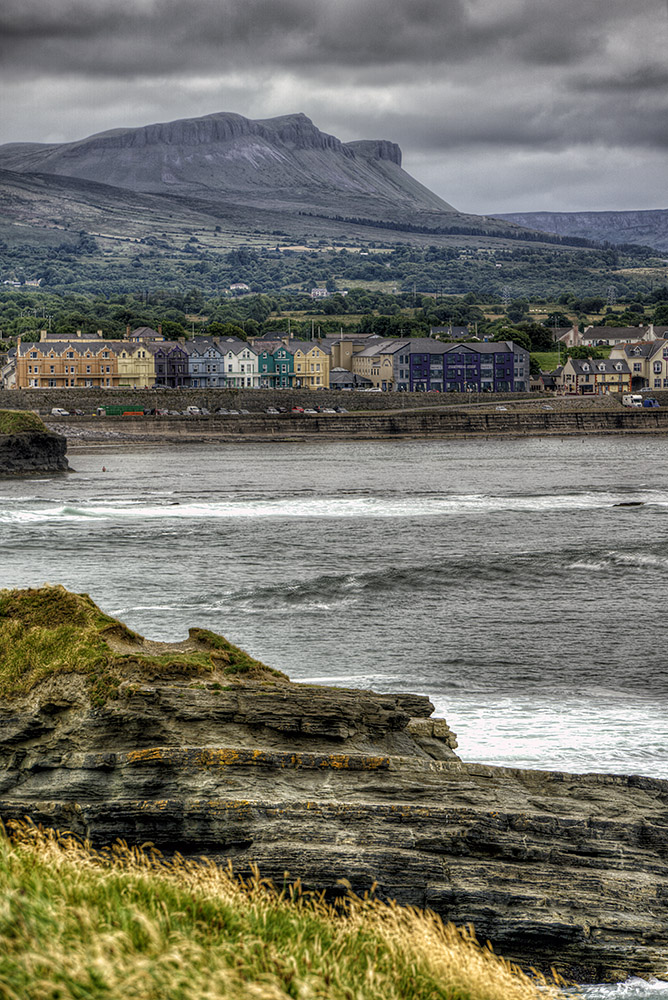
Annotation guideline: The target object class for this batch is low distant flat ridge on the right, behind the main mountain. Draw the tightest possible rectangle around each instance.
[494,208,668,252]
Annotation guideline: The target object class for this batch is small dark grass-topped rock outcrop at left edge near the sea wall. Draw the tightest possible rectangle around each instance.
[0,410,69,476]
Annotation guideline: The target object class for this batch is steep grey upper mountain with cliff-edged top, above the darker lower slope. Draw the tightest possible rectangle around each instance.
[0,112,455,218]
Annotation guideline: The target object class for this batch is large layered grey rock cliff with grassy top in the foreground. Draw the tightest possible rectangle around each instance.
[0,587,668,981]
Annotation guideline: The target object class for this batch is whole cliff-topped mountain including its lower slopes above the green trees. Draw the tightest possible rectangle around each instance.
[0,112,616,270]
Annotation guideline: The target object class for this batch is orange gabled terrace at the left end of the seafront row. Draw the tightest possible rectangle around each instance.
[16,337,118,389]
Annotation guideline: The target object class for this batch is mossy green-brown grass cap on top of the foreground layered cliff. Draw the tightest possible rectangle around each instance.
[0,585,285,704]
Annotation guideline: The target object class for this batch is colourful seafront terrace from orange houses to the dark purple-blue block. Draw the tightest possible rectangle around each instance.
[2,327,530,392]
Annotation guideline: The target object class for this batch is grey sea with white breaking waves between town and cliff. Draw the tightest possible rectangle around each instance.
[0,436,668,1000]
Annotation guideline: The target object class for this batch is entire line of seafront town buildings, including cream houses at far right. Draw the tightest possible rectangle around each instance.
[1,324,668,395]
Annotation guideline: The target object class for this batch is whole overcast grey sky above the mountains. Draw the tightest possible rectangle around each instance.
[0,0,668,214]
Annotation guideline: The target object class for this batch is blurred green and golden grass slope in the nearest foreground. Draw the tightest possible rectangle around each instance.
[0,823,556,1000]
